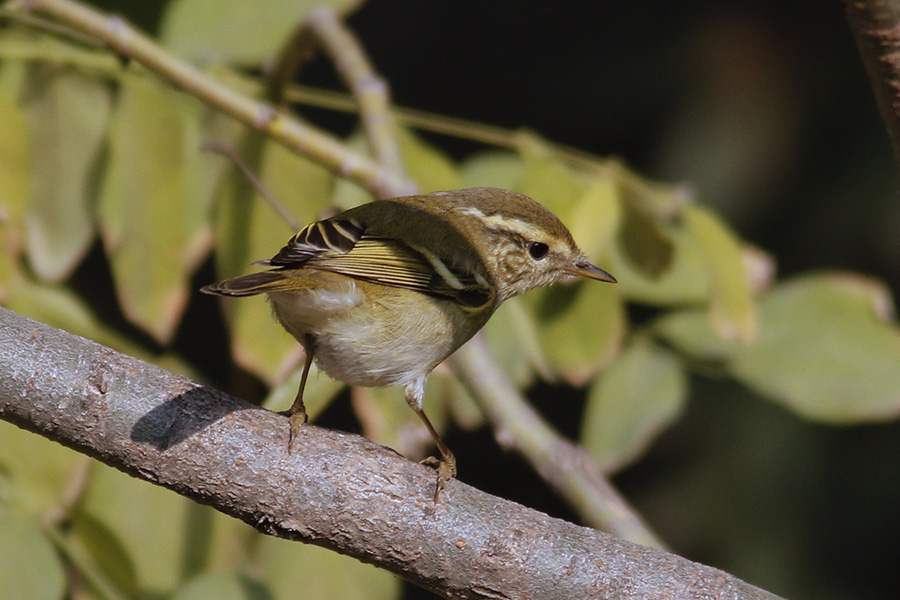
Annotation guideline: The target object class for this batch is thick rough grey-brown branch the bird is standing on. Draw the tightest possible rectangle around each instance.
[0,309,776,600]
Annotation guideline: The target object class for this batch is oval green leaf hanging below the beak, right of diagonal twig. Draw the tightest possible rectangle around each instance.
[581,337,687,472]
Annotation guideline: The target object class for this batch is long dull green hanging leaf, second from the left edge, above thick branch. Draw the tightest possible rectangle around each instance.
[25,64,111,281]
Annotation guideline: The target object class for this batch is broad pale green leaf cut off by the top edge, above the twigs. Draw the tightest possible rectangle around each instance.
[160,0,360,66]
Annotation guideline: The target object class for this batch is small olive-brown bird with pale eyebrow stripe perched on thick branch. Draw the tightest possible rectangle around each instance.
[201,188,615,500]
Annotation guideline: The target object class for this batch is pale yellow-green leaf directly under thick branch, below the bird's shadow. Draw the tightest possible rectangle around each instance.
[79,463,195,596]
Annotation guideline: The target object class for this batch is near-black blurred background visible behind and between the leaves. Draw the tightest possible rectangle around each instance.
[91,0,900,599]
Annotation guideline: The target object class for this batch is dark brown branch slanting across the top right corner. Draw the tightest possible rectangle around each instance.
[844,0,900,173]
